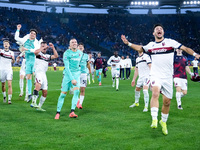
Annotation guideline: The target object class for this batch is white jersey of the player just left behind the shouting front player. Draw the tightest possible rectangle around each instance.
[135,53,151,78]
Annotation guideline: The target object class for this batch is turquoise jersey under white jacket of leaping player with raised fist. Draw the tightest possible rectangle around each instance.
[24,39,35,64]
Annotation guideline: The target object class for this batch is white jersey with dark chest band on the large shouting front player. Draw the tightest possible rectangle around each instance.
[143,38,181,78]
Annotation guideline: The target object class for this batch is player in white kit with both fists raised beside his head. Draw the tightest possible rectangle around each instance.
[31,42,58,111]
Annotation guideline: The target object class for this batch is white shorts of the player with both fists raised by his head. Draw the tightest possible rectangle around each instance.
[35,72,48,90]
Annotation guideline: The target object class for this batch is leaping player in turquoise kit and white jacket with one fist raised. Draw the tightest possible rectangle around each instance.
[15,24,42,102]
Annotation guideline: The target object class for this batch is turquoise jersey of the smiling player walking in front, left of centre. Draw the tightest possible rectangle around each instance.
[63,49,83,81]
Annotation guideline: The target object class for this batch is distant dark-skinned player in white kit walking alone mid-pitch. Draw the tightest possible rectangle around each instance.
[107,51,121,91]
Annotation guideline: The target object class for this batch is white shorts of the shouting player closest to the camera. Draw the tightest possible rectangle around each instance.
[150,77,173,99]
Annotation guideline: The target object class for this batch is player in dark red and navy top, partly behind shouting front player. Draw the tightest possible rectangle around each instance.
[174,49,194,110]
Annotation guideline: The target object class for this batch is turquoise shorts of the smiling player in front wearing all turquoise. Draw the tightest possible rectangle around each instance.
[61,75,80,92]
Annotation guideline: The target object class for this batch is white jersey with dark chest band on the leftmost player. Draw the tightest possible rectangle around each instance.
[0,49,14,70]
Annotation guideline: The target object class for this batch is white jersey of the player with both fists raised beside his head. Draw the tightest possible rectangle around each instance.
[35,52,51,73]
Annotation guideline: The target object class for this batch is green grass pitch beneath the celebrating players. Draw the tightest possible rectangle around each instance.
[0,71,200,150]
